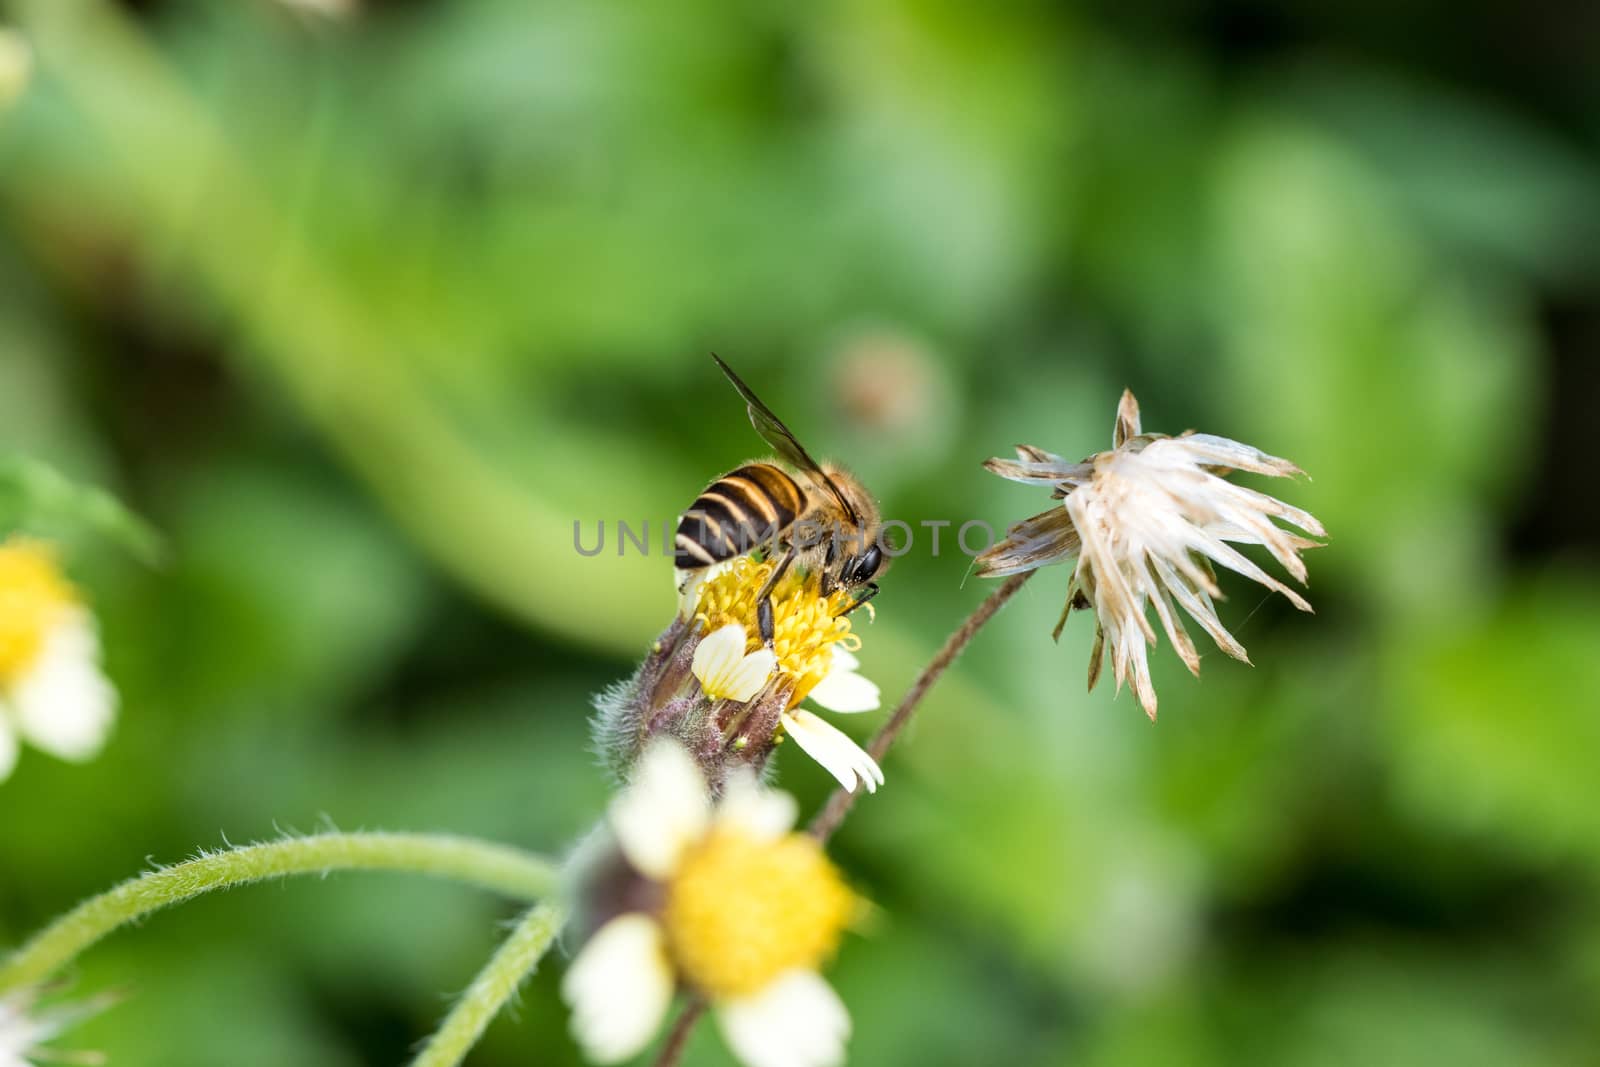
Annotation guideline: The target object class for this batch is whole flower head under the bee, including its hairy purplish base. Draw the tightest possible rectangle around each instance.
[597,557,883,792]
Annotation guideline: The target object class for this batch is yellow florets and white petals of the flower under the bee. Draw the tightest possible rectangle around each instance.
[691,557,883,792]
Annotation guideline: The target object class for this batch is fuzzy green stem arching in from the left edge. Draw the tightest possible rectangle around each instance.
[0,833,557,993]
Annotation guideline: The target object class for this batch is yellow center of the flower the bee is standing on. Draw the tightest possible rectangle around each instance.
[694,557,872,707]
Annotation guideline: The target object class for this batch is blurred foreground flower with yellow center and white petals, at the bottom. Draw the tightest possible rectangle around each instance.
[562,741,861,1067]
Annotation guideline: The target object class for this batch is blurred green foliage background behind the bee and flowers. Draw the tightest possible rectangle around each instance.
[0,0,1600,1067]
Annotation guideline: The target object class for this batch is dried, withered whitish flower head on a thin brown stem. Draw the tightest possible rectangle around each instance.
[978,392,1326,718]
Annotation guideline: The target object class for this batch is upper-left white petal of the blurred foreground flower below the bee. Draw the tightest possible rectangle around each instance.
[610,739,710,881]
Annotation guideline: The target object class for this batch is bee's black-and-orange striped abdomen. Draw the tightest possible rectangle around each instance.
[674,464,805,571]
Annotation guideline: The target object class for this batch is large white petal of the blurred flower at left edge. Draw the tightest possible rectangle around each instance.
[11,611,117,761]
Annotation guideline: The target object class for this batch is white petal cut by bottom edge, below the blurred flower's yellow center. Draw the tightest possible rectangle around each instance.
[717,971,850,1067]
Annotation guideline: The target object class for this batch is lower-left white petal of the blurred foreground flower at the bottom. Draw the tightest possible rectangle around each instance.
[562,913,675,1064]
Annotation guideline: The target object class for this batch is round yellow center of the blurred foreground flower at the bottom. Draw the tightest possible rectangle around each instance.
[662,827,858,998]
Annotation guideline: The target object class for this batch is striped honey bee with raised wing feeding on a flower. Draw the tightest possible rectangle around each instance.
[674,354,885,645]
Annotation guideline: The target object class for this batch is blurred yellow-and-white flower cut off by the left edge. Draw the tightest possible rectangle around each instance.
[0,537,117,781]
